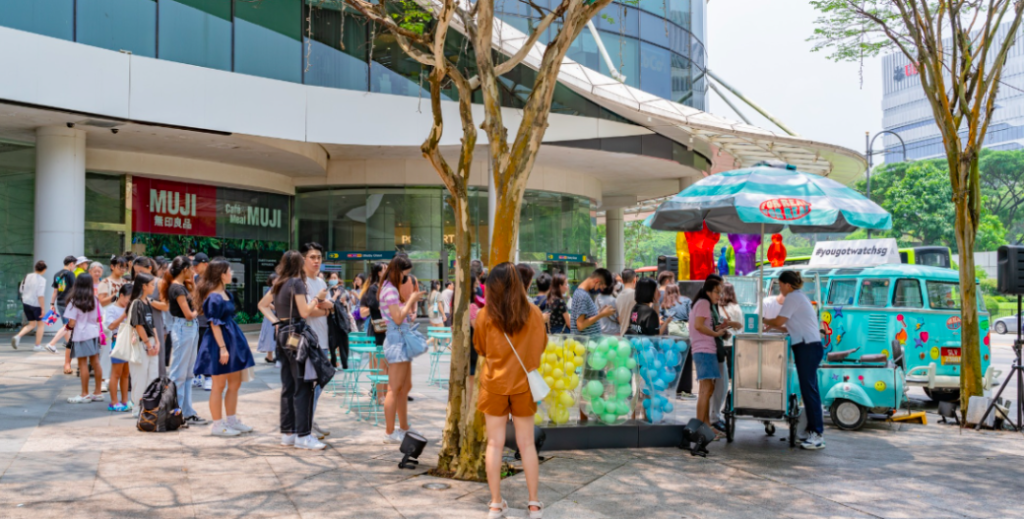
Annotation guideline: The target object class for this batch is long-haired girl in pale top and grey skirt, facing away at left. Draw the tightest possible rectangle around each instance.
[65,272,103,403]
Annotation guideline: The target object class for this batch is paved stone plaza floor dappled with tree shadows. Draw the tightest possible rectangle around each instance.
[0,337,1024,519]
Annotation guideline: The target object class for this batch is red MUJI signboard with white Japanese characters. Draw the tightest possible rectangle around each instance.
[132,177,217,236]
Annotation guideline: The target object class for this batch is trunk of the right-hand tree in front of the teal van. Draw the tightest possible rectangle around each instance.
[948,152,982,415]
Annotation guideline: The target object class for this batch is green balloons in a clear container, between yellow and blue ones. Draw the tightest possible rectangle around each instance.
[582,337,637,425]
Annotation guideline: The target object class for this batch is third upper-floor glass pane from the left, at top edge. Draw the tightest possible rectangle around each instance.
[159,0,231,71]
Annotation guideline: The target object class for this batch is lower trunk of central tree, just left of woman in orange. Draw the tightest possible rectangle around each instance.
[428,192,486,481]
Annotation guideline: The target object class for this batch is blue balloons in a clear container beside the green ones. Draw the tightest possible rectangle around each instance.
[629,336,689,424]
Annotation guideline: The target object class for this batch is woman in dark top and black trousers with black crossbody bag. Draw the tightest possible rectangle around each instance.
[270,251,327,450]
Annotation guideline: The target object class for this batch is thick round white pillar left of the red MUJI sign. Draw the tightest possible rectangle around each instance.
[34,126,85,304]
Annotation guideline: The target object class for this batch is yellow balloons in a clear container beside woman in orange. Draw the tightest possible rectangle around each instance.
[534,336,587,425]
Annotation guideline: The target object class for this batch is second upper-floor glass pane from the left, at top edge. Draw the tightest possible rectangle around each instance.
[75,0,157,57]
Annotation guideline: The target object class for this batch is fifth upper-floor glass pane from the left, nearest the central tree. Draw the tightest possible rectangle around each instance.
[305,0,370,92]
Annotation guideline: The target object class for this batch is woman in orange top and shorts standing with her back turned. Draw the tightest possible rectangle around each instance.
[473,263,548,519]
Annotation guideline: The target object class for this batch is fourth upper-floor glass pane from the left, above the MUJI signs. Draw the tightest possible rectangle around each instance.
[234,0,302,83]
